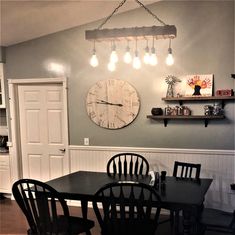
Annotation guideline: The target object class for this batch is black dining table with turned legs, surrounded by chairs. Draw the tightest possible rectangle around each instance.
[46,171,212,235]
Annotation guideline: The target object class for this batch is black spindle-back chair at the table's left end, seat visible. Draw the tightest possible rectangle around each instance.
[12,179,94,235]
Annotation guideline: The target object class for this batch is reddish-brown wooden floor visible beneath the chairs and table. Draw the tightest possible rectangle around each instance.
[0,199,228,235]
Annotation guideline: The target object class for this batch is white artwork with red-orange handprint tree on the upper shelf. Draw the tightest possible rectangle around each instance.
[185,74,213,96]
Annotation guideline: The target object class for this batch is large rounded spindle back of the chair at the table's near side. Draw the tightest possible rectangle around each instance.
[93,181,161,235]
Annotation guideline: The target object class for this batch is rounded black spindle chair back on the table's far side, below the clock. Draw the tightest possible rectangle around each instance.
[107,153,149,176]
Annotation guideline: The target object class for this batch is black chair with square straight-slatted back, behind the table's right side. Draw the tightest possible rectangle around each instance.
[160,161,203,234]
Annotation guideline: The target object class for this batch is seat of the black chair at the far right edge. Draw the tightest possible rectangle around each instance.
[200,208,233,228]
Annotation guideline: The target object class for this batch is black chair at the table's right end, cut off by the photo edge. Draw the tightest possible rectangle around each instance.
[200,208,235,235]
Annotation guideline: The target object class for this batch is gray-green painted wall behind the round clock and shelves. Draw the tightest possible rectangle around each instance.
[6,1,235,150]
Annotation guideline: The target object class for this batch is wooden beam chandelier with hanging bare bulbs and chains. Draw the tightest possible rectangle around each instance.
[85,0,176,71]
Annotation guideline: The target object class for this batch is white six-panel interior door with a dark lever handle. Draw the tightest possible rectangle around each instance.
[18,84,69,181]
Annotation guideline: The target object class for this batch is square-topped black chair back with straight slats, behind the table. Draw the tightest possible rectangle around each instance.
[173,161,201,179]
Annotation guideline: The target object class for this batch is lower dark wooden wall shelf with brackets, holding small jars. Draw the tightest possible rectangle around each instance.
[147,115,225,127]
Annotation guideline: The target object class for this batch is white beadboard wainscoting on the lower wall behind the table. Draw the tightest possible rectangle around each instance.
[69,145,235,211]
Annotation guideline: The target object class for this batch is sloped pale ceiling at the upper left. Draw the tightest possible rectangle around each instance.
[0,0,159,46]
